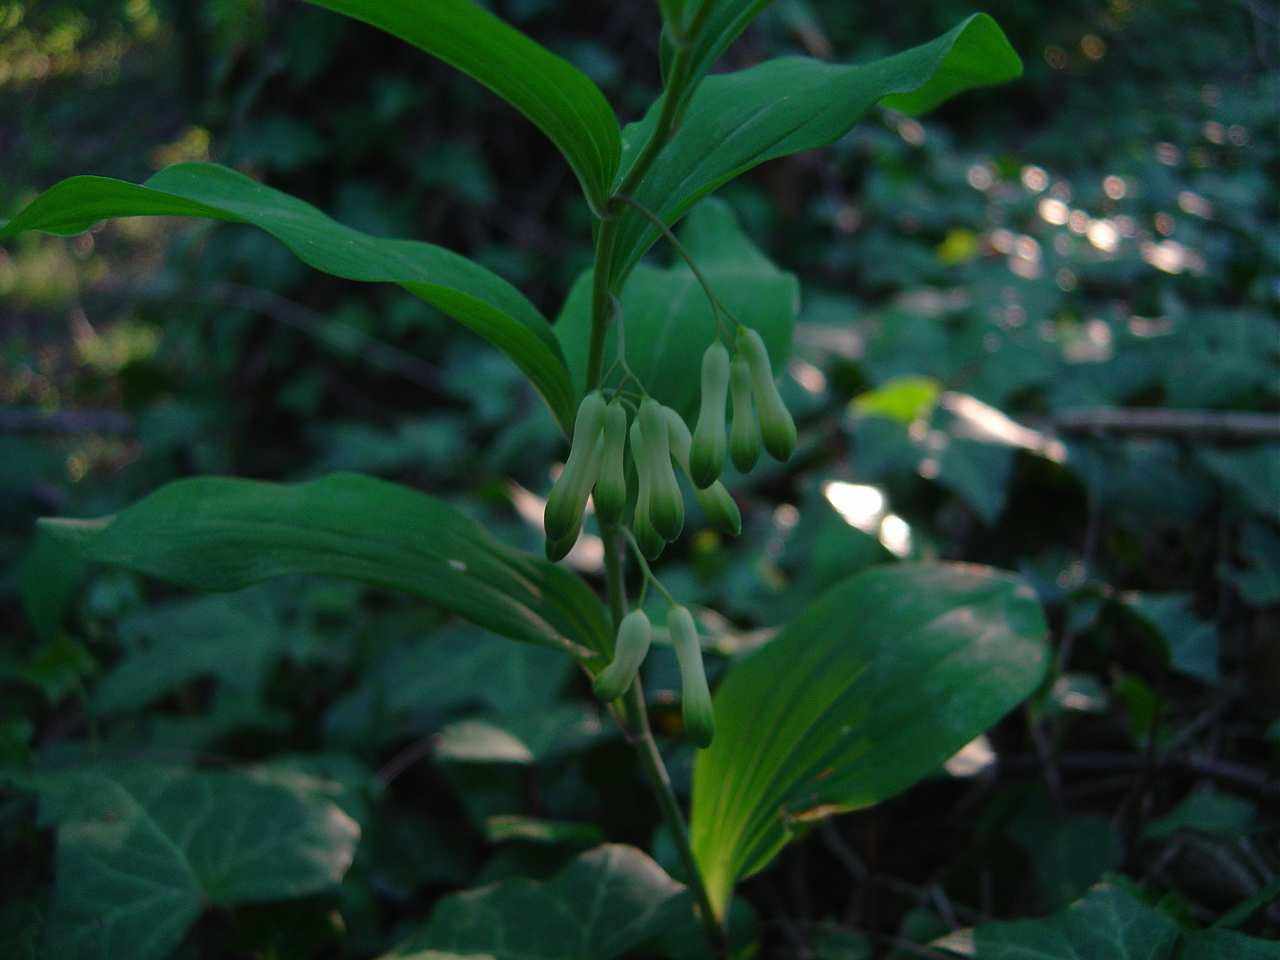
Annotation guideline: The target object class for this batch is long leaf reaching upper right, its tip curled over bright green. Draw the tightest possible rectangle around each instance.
[614,14,1021,279]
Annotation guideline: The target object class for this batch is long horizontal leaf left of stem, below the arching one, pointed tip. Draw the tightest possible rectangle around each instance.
[41,474,611,666]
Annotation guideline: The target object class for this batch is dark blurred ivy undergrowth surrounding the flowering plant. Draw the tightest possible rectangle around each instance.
[0,0,1280,960]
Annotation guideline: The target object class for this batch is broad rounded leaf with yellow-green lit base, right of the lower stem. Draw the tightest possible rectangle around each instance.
[691,564,1048,909]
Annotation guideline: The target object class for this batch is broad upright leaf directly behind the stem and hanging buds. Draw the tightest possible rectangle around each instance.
[556,201,800,416]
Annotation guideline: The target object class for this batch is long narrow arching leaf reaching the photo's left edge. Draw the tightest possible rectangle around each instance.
[0,164,575,429]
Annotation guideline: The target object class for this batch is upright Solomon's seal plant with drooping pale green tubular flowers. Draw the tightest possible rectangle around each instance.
[0,0,1046,960]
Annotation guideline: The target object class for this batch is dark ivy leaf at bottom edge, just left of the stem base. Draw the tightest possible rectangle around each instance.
[383,844,687,960]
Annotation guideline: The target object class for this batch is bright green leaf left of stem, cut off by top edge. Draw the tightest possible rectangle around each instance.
[300,0,622,211]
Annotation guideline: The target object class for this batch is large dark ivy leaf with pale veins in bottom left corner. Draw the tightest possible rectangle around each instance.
[42,768,360,960]
